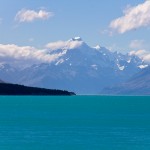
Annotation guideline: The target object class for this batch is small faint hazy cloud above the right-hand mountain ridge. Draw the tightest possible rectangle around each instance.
[129,40,145,49]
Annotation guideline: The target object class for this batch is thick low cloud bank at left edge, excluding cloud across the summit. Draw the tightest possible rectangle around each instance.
[0,44,63,65]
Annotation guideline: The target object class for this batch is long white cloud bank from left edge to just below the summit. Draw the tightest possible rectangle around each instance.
[0,39,83,65]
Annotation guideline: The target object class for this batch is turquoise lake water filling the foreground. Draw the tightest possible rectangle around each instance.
[0,96,150,150]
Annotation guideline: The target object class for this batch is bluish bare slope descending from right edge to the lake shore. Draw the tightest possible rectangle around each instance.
[100,67,150,95]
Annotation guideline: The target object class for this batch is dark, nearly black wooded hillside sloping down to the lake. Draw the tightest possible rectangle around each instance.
[0,82,75,96]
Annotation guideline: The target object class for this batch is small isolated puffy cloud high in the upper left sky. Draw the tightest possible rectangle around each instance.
[15,9,54,22]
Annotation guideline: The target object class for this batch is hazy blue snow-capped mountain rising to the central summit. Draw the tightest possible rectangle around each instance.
[0,37,147,94]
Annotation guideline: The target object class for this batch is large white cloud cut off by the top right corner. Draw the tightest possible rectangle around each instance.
[110,0,150,34]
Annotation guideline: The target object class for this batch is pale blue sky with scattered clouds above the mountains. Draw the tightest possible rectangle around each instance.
[0,0,150,65]
